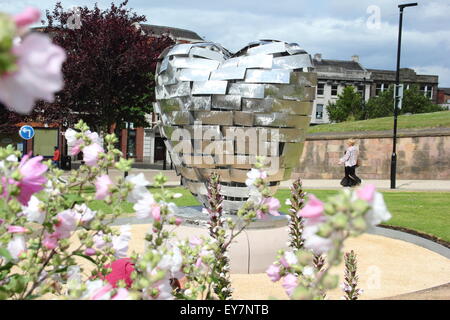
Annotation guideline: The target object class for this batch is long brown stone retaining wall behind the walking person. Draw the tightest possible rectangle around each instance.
[295,128,450,180]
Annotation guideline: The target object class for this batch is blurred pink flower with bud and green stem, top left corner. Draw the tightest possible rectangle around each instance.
[0,8,66,113]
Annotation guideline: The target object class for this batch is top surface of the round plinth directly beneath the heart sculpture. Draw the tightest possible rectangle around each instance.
[175,206,288,229]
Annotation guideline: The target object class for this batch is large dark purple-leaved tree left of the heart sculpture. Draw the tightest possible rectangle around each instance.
[45,1,174,131]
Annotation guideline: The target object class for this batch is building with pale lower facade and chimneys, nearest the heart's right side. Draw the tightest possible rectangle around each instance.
[311,53,371,124]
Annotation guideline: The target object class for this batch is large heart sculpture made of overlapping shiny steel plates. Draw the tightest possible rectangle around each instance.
[154,40,317,214]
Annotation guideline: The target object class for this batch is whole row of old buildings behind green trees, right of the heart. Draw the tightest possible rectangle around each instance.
[311,53,439,125]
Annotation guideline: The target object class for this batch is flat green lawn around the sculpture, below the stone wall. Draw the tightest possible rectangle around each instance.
[81,187,450,241]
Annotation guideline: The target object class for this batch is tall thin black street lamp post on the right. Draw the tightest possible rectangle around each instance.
[391,2,417,189]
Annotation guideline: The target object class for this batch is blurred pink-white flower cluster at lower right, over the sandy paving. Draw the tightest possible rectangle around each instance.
[267,185,391,299]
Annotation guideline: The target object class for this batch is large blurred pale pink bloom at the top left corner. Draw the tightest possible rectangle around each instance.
[0,32,66,114]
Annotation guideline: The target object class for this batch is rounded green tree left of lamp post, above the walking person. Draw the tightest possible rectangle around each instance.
[327,86,364,122]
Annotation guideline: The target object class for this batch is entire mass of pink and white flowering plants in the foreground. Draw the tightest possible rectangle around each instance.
[0,5,390,300]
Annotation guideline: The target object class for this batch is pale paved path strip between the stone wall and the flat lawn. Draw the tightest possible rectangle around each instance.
[100,168,450,192]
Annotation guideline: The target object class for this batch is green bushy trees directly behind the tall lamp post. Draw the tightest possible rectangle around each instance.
[367,85,444,119]
